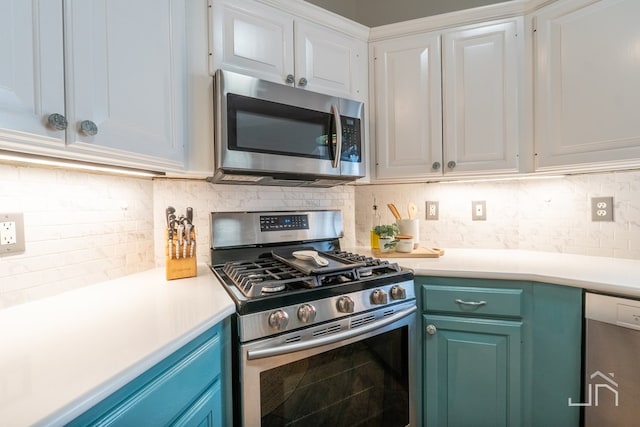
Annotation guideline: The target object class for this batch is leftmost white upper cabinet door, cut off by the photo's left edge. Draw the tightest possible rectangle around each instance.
[0,0,65,151]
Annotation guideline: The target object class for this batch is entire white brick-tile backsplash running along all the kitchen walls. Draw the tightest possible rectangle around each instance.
[0,164,640,308]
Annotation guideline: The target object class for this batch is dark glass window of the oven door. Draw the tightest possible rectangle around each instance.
[260,326,409,427]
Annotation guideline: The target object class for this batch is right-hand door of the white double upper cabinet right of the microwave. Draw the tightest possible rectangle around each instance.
[442,18,524,175]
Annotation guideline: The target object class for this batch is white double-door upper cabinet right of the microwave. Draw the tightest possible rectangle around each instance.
[373,17,524,181]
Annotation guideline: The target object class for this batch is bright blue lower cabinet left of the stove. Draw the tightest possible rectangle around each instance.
[69,321,230,427]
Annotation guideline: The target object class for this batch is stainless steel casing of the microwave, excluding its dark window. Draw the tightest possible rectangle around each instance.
[211,70,366,187]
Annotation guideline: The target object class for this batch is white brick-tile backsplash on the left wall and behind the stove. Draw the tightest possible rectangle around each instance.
[0,164,355,309]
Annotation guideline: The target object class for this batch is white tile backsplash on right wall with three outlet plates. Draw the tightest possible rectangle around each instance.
[355,171,640,259]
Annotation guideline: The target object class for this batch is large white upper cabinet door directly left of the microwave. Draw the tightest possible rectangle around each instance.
[65,0,186,169]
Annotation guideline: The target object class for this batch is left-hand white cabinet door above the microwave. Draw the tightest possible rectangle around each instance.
[210,0,294,83]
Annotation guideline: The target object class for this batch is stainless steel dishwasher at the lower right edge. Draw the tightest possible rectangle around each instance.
[580,292,640,427]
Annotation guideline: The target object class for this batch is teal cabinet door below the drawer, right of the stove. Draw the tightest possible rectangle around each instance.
[423,315,522,427]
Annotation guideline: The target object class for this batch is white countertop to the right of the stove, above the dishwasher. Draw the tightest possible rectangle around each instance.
[358,248,640,298]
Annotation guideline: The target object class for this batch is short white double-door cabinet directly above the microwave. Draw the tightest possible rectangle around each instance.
[210,0,368,99]
